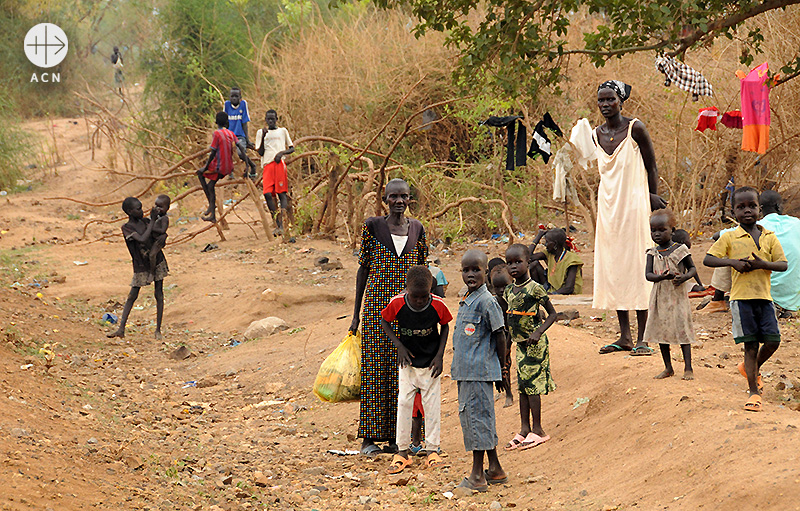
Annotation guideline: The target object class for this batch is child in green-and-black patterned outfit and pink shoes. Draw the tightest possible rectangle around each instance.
[503,243,556,451]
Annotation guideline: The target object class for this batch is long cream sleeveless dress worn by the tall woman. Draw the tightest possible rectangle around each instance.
[592,119,653,310]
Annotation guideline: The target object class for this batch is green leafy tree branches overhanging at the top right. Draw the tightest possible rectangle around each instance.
[368,0,800,95]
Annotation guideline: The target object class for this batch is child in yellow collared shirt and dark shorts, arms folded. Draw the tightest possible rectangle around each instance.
[703,186,787,412]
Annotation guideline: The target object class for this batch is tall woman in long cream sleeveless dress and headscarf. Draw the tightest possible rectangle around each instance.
[592,80,666,355]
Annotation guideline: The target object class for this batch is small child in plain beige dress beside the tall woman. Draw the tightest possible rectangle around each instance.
[644,209,697,380]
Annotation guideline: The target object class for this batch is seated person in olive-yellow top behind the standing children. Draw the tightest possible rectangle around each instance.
[531,229,583,295]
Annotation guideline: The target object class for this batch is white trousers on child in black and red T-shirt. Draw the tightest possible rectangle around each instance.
[397,365,442,451]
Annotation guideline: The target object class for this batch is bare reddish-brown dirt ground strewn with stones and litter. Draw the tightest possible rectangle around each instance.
[0,119,800,511]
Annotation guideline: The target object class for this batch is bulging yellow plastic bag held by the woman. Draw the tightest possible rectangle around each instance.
[313,332,361,403]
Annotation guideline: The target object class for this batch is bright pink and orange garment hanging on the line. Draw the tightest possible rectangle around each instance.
[736,62,770,154]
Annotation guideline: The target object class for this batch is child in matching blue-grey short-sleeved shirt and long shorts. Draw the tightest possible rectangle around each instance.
[450,249,508,492]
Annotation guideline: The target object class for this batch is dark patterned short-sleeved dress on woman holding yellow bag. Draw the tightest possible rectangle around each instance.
[358,217,428,442]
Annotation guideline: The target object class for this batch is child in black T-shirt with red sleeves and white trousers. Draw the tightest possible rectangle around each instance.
[381,266,453,474]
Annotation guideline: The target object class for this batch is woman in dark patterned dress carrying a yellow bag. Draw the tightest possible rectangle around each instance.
[350,179,428,455]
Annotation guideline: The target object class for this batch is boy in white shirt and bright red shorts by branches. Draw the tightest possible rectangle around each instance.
[256,109,294,236]
